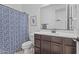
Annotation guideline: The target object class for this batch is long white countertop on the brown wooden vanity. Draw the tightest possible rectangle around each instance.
[34,31,77,38]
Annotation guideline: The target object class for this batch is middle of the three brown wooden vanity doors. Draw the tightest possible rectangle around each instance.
[51,43,63,54]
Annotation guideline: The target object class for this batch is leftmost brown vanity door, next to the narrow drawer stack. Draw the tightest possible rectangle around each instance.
[41,40,50,54]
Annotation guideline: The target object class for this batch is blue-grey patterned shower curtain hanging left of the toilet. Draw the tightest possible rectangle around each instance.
[0,5,28,53]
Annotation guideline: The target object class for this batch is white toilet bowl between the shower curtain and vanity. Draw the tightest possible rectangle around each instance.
[22,41,33,54]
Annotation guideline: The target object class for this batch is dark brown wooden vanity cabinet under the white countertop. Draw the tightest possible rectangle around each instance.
[34,34,76,54]
